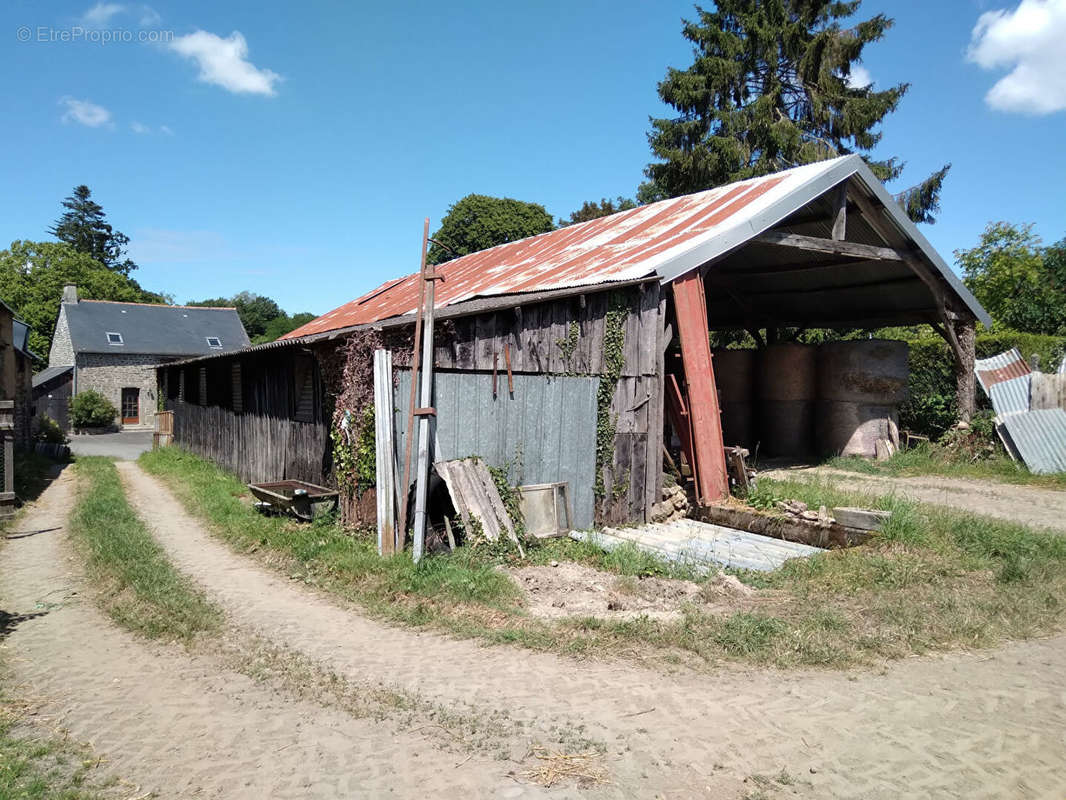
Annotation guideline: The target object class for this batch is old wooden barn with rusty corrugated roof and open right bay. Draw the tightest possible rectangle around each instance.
[159,156,989,533]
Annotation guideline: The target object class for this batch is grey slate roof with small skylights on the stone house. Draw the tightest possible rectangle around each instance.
[63,300,251,356]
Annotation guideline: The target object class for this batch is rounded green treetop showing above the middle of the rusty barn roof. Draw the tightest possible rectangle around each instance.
[427,194,555,263]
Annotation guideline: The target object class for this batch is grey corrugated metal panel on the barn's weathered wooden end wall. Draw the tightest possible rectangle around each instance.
[393,369,599,528]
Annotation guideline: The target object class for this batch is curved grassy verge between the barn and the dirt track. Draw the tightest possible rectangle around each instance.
[141,448,1066,667]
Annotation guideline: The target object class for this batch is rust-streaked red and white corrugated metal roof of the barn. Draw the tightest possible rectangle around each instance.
[282,155,989,339]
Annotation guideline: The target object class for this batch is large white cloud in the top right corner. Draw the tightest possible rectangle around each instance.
[966,0,1066,114]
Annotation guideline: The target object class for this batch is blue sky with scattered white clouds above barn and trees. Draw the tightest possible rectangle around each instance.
[0,0,1066,314]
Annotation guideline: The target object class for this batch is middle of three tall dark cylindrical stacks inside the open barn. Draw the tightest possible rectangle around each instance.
[756,342,818,459]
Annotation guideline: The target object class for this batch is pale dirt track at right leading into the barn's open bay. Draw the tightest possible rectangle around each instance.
[759,467,1066,533]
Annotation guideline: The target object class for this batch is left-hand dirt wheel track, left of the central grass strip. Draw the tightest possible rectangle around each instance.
[0,469,562,800]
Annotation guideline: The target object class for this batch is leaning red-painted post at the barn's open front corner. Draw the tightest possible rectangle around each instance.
[673,270,729,503]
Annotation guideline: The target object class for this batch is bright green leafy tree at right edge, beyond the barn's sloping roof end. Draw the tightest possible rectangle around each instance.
[955,222,1066,334]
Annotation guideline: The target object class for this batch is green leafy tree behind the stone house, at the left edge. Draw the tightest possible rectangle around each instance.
[0,241,166,357]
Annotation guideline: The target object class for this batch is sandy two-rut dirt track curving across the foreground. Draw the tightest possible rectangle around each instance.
[3,464,1066,799]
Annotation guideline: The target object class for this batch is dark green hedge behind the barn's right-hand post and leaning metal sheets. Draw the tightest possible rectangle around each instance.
[900,331,1066,438]
